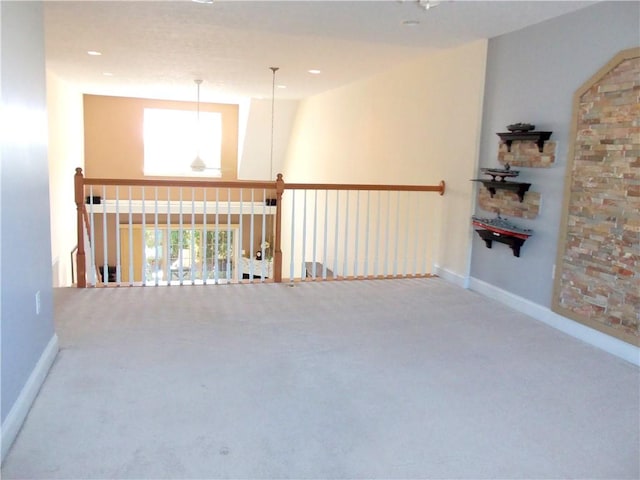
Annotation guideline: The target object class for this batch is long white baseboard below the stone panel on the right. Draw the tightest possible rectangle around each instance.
[468,277,640,366]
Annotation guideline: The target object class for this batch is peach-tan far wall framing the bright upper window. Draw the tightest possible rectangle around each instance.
[84,95,238,180]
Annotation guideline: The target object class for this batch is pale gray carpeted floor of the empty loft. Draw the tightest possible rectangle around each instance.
[2,279,640,479]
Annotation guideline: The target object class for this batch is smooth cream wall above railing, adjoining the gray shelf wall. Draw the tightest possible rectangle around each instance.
[283,40,487,277]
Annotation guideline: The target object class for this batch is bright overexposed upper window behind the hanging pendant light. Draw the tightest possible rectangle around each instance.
[144,108,222,177]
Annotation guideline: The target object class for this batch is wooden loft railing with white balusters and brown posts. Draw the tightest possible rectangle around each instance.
[74,168,445,288]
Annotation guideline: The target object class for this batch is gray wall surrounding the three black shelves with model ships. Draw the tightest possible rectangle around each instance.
[471,2,640,306]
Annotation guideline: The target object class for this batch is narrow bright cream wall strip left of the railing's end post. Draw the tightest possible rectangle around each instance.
[47,72,84,287]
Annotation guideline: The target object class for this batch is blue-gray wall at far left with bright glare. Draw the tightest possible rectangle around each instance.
[0,1,54,422]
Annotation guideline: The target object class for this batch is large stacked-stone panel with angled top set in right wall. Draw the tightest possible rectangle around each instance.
[556,57,640,344]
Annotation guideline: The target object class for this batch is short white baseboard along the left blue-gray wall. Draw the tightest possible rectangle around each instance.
[0,333,58,461]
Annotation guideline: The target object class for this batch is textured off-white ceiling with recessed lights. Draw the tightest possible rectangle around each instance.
[44,0,594,101]
